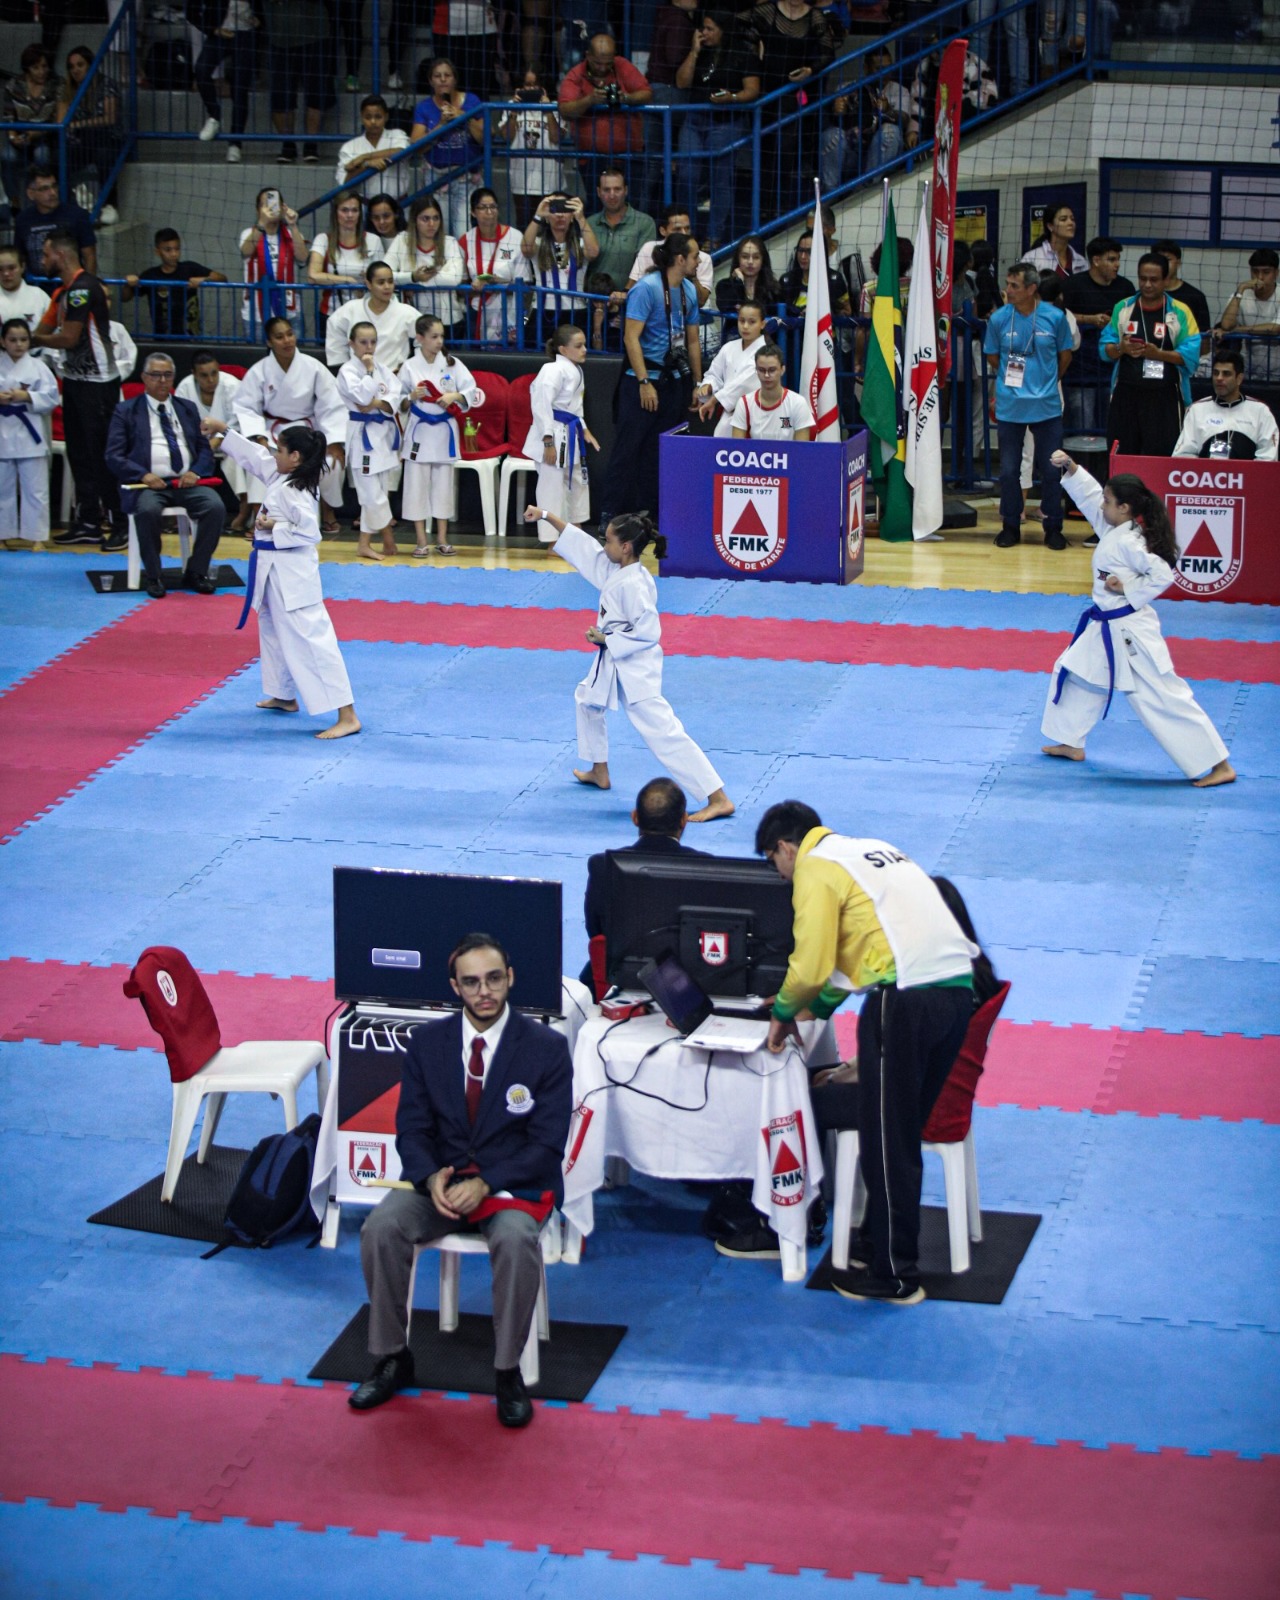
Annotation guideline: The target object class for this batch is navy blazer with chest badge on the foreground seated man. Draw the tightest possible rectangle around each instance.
[395,1011,573,1205]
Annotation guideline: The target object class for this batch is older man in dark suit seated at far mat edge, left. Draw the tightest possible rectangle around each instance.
[107,352,227,600]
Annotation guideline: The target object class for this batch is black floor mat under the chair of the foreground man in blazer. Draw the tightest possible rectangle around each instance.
[307,1306,627,1400]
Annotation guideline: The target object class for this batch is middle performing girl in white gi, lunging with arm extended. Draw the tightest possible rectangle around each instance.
[525,506,733,822]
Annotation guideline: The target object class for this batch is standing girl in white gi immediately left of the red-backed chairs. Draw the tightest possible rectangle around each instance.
[400,317,483,557]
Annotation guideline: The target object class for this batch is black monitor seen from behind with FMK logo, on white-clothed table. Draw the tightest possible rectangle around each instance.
[605,850,792,995]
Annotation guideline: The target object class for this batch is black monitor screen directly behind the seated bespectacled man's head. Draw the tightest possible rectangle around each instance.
[333,867,562,1014]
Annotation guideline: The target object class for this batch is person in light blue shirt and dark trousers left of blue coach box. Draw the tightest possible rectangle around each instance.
[602,234,702,525]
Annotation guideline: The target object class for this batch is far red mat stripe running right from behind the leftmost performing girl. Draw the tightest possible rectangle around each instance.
[328,600,1280,683]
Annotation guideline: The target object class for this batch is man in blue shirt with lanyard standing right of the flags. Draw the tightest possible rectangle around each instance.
[982,261,1070,550]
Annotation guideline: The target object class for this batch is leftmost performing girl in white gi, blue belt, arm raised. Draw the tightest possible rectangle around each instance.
[200,418,360,739]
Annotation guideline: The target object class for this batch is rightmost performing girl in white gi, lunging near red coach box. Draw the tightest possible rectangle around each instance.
[1040,450,1235,789]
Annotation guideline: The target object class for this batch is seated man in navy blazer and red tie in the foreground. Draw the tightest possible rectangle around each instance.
[349,933,573,1427]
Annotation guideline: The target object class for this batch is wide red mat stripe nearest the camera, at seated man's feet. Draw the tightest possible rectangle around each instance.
[0,1357,1280,1600]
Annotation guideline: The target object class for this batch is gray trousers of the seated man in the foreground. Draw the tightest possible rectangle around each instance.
[360,1189,542,1370]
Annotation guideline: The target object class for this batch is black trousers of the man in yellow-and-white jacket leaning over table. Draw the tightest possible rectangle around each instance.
[858,984,973,1288]
